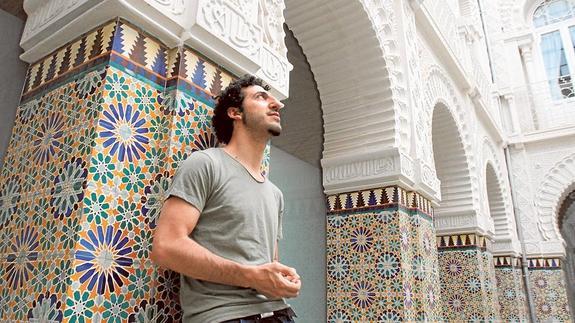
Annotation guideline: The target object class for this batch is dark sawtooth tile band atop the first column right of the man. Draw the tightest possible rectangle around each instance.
[327,186,433,218]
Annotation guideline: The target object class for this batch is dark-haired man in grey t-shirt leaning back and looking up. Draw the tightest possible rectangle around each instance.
[151,75,301,323]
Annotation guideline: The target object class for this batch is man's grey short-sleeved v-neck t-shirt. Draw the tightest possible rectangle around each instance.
[168,148,288,323]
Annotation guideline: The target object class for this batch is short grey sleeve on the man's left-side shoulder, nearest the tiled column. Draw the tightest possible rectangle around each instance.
[166,151,214,212]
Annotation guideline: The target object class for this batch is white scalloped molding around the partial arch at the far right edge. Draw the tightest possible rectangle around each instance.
[534,153,575,241]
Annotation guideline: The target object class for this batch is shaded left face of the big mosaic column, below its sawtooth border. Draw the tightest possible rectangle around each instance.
[0,65,106,321]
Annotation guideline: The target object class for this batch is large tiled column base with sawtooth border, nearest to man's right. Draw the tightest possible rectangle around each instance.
[327,186,442,322]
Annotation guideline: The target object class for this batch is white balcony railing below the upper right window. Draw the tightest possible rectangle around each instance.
[513,75,575,134]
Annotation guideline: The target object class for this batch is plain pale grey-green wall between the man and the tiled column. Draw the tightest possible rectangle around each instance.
[270,146,327,322]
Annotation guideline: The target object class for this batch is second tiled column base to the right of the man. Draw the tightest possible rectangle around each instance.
[437,234,500,321]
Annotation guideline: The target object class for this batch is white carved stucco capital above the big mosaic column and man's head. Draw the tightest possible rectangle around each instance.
[20,0,292,99]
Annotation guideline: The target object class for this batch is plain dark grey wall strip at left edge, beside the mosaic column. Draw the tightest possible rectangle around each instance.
[0,9,27,169]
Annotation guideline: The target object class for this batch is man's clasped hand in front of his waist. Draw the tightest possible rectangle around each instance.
[247,261,301,298]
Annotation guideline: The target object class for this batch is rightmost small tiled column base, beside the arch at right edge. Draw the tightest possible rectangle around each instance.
[529,258,572,322]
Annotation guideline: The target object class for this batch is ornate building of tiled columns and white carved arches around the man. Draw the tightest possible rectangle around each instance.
[0,0,575,322]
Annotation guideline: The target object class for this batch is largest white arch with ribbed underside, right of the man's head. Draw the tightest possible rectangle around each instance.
[286,0,415,194]
